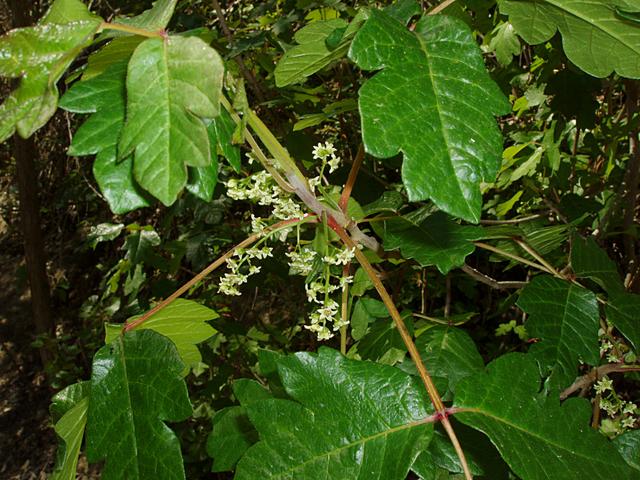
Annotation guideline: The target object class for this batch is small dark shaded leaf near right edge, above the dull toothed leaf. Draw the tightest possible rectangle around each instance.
[571,235,624,294]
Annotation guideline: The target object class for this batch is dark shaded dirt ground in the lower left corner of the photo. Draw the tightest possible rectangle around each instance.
[0,254,98,480]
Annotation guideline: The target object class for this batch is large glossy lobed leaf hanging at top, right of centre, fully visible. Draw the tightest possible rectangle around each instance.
[349,11,511,222]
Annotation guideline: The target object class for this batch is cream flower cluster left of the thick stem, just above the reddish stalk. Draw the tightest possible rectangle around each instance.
[226,170,304,220]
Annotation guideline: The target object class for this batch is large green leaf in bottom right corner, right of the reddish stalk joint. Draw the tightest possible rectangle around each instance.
[454,353,632,480]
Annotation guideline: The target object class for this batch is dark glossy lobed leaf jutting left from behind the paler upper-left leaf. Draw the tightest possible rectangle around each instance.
[60,61,149,214]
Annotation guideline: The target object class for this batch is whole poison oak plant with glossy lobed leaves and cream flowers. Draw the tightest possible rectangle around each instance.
[0,0,640,480]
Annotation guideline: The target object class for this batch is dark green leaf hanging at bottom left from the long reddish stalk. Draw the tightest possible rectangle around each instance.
[87,330,191,480]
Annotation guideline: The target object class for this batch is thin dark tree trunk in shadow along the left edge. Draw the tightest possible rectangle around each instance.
[9,0,55,366]
